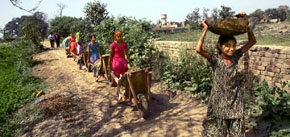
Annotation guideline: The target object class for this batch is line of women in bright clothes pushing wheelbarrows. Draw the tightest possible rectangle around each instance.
[62,31,132,92]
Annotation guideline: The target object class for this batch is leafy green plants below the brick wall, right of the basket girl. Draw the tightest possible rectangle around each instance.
[246,78,290,136]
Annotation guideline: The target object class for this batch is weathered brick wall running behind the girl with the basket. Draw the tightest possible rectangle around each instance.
[154,41,290,92]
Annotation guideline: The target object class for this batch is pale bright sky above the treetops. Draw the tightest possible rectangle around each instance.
[0,0,290,28]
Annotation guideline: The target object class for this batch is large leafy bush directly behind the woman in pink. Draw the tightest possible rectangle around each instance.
[94,16,158,68]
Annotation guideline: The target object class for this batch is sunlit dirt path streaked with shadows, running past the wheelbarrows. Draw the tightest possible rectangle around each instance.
[22,42,206,137]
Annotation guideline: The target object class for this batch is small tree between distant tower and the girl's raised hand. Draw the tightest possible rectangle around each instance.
[185,8,201,28]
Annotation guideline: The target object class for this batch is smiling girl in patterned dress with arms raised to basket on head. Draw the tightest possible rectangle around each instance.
[196,13,256,137]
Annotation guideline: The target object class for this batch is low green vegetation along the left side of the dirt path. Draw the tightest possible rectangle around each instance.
[0,41,42,136]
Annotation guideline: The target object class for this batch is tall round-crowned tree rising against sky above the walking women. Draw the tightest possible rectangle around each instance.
[84,1,108,25]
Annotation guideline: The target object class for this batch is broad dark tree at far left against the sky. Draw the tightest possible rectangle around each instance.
[5,12,48,38]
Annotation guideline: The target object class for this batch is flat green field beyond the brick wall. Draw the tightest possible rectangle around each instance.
[160,24,290,46]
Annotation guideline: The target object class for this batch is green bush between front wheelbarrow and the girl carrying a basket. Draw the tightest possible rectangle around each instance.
[161,48,213,101]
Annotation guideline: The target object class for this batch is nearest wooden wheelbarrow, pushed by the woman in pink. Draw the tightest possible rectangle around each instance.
[111,68,152,119]
